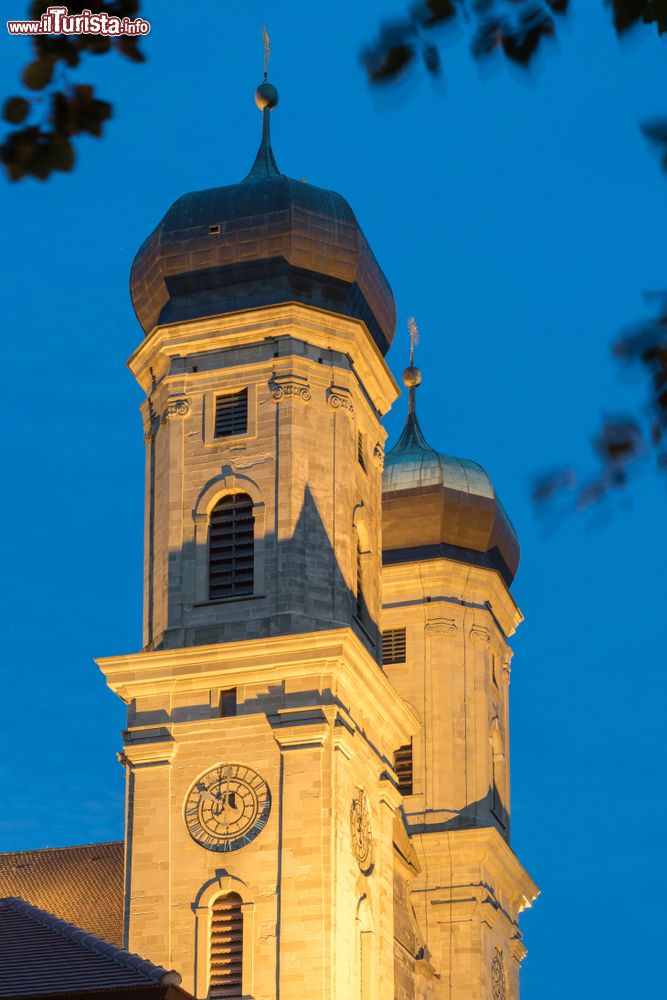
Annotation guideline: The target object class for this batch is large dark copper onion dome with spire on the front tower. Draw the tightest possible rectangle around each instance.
[130,81,396,354]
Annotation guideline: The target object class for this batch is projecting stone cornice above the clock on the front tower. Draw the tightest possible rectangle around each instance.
[95,629,420,754]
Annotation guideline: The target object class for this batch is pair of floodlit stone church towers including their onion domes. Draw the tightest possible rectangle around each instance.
[98,74,536,1000]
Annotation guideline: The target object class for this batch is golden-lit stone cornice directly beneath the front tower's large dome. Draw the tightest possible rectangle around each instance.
[128,303,400,414]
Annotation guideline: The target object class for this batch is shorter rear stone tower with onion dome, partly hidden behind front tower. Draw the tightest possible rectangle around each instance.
[382,350,537,1000]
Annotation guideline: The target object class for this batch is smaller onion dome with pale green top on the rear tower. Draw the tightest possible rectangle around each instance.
[382,364,519,586]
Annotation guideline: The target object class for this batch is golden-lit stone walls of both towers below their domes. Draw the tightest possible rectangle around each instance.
[98,252,537,1000]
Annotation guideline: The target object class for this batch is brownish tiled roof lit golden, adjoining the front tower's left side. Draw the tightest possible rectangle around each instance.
[0,841,123,946]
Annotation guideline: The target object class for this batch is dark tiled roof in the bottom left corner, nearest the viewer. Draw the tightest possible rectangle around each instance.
[0,899,180,997]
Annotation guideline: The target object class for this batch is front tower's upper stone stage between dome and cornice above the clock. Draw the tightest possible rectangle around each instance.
[130,305,397,654]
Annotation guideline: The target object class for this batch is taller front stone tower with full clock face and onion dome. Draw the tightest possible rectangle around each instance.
[98,76,418,1000]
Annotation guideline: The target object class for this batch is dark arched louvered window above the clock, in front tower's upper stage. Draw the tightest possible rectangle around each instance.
[208,493,255,601]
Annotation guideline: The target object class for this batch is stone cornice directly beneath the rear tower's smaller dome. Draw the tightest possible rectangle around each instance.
[382,556,523,637]
